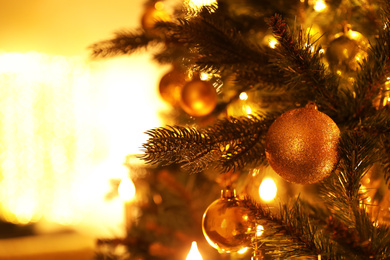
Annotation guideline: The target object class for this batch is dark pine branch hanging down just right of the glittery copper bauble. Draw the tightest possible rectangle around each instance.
[321,131,390,259]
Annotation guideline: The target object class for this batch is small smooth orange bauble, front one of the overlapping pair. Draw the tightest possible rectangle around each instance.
[180,79,218,117]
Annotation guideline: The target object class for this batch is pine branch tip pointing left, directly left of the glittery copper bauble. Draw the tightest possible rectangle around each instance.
[142,116,274,173]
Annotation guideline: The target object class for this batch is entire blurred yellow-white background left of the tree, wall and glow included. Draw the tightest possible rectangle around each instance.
[0,0,168,259]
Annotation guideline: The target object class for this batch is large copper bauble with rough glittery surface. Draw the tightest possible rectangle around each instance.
[265,108,340,184]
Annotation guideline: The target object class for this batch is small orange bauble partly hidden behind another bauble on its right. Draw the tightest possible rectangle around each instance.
[159,68,186,107]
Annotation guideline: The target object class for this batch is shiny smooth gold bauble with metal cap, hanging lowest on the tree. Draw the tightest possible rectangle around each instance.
[202,189,255,253]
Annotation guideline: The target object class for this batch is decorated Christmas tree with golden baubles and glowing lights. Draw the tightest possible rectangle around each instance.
[92,0,390,259]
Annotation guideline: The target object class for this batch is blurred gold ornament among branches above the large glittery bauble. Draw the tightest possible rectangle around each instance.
[325,25,369,74]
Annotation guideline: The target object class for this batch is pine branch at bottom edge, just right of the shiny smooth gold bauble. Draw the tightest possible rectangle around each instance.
[243,198,339,259]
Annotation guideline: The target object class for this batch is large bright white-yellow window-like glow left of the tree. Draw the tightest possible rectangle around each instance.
[0,52,162,236]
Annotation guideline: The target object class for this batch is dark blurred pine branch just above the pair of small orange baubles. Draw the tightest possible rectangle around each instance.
[173,8,284,89]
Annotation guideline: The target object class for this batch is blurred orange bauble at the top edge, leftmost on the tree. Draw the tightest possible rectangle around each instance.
[141,1,171,32]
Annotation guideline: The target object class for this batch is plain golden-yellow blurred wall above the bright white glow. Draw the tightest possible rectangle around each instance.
[0,0,145,55]
